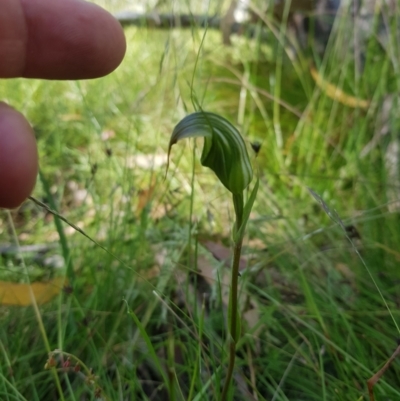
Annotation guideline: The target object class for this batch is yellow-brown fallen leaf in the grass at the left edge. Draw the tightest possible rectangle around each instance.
[0,277,67,306]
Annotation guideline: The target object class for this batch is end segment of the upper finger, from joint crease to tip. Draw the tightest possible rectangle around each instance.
[21,0,126,79]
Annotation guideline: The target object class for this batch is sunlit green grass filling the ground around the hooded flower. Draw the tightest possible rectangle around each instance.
[0,1,400,401]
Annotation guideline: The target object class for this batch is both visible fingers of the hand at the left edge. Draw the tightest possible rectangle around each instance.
[0,0,126,208]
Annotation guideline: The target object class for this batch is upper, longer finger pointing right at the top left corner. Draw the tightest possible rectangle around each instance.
[0,0,126,79]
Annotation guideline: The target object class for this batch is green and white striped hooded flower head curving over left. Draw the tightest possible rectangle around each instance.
[168,111,253,194]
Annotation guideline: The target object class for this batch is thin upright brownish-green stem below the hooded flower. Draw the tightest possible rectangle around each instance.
[221,194,244,401]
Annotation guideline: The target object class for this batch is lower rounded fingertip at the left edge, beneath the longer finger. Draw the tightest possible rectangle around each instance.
[0,102,38,208]
